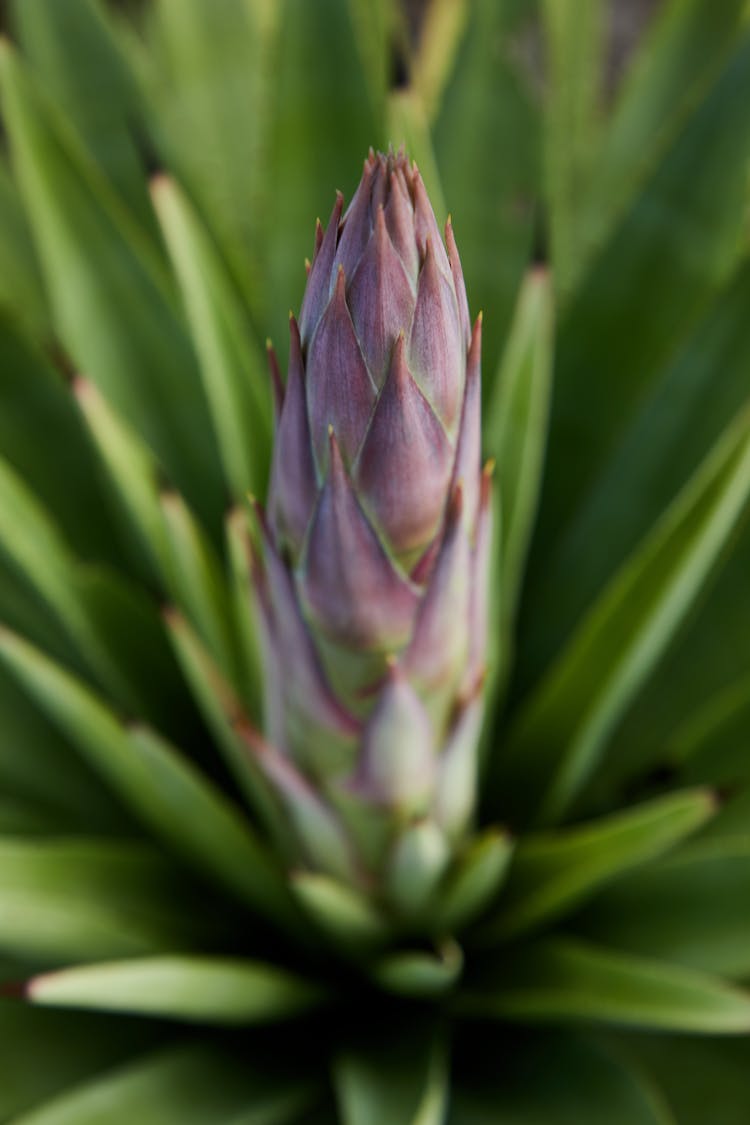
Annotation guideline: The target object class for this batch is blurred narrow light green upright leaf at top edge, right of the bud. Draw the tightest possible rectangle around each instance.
[542,0,605,299]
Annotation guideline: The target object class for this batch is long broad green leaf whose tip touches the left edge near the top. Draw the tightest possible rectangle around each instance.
[0,45,223,527]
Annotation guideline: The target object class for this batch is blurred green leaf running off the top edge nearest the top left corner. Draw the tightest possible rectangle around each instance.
[12,0,156,240]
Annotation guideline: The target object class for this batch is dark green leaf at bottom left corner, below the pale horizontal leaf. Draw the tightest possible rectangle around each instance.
[0,999,160,1125]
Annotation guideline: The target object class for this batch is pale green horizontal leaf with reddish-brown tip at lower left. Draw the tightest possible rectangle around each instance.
[26,955,324,1026]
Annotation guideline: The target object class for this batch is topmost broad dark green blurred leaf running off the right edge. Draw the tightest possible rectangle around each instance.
[525,32,750,643]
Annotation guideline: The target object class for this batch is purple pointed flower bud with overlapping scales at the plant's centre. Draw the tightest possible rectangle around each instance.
[256,153,490,881]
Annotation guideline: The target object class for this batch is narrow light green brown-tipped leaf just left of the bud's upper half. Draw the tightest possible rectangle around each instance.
[152,176,271,498]
